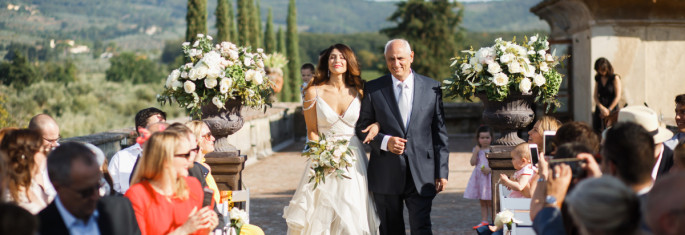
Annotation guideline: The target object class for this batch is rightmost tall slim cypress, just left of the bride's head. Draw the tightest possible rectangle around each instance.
[286,0,301,101]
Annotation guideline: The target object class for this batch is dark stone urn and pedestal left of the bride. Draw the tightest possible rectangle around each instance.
[202,100,246,191]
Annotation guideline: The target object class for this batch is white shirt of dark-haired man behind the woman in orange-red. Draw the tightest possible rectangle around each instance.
[107,144,143,194]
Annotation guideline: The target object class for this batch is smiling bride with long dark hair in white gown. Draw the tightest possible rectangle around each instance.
[283,44,380,235]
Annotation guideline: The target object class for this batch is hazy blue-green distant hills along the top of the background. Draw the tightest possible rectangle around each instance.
[0,0,548,49]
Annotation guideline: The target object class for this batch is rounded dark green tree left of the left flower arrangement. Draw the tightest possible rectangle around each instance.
[105,52,166,84]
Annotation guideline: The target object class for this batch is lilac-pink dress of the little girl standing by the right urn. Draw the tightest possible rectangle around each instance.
[464,149,492,200]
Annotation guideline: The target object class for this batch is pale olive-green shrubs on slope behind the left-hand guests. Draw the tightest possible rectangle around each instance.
[0,76,183,137]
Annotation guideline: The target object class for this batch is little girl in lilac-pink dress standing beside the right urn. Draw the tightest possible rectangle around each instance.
[464,126,492,229]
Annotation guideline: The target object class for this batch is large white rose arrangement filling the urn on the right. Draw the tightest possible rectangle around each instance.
[443,35,565,111]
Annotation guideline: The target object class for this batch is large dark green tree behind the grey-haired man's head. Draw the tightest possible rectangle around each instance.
[381,0,463,80]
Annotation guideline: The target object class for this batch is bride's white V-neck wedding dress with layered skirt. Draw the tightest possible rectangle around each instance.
[283,95,380,235]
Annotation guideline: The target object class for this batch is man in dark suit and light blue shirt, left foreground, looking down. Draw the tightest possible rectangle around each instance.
[38,142,140,235]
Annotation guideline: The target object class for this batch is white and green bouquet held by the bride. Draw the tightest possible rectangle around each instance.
[302,134,355,188]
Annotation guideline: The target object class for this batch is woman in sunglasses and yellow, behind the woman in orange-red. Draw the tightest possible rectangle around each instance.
[186,121,220,204]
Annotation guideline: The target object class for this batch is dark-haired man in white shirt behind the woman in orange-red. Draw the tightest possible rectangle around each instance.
[107,107,166,194]
